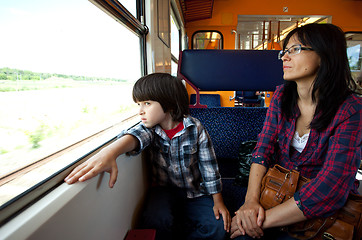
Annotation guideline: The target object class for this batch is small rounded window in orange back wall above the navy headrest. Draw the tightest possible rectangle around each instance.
[192,31,223,49]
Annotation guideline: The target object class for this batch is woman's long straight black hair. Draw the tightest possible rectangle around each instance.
[281,23,357,131]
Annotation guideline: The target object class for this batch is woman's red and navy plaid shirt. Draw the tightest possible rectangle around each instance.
[252,86,362,218]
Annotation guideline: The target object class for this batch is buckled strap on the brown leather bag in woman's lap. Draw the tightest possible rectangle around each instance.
[274,170,299,203]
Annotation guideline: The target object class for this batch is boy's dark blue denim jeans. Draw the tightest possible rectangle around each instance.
[141,187,226,240]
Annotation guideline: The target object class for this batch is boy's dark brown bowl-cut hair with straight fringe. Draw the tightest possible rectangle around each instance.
[132,73,189,121]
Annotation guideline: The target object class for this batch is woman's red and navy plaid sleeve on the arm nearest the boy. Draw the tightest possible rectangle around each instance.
[251,86,282,168]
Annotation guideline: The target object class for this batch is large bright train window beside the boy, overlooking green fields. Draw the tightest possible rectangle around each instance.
[0,0,144,224]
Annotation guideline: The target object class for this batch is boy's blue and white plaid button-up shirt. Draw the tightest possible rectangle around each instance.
[119,117,221,198]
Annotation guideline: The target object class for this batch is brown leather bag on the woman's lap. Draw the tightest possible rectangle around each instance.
[260,165,362,240]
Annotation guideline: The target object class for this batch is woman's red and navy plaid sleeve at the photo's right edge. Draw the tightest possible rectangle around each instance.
[294,100,362,218]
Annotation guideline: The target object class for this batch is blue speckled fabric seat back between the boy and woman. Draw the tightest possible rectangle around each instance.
[190,107,267,212]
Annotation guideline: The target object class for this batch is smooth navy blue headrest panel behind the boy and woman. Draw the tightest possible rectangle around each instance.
[178,50,283,108]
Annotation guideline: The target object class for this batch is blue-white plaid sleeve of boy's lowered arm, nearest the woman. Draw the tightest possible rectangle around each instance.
[198,124,221,194]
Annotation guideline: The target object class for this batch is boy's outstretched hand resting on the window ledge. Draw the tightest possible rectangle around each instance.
[64,150,118,188]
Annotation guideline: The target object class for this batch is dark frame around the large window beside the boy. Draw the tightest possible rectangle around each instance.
[0,0,148,226]
